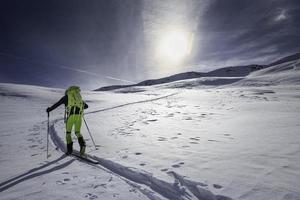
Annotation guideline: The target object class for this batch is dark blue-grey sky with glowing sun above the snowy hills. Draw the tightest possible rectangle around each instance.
[0,0,300,89]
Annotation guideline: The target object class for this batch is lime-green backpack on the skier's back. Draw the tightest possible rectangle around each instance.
[66,86,84,116]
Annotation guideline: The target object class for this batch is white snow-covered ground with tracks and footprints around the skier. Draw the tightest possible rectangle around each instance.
[0,60,300,200]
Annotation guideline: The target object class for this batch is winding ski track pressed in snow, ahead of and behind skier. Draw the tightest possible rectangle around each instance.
[50,93,231,200]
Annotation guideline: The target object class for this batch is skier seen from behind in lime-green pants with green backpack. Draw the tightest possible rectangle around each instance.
[46,86,88,155]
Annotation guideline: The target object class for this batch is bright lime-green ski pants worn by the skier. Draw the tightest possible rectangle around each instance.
[66,115,82,144]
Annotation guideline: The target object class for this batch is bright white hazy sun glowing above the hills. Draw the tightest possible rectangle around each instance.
[157,30,191,64]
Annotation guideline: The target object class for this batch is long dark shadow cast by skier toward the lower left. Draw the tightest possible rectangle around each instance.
[0,155,75,192]
